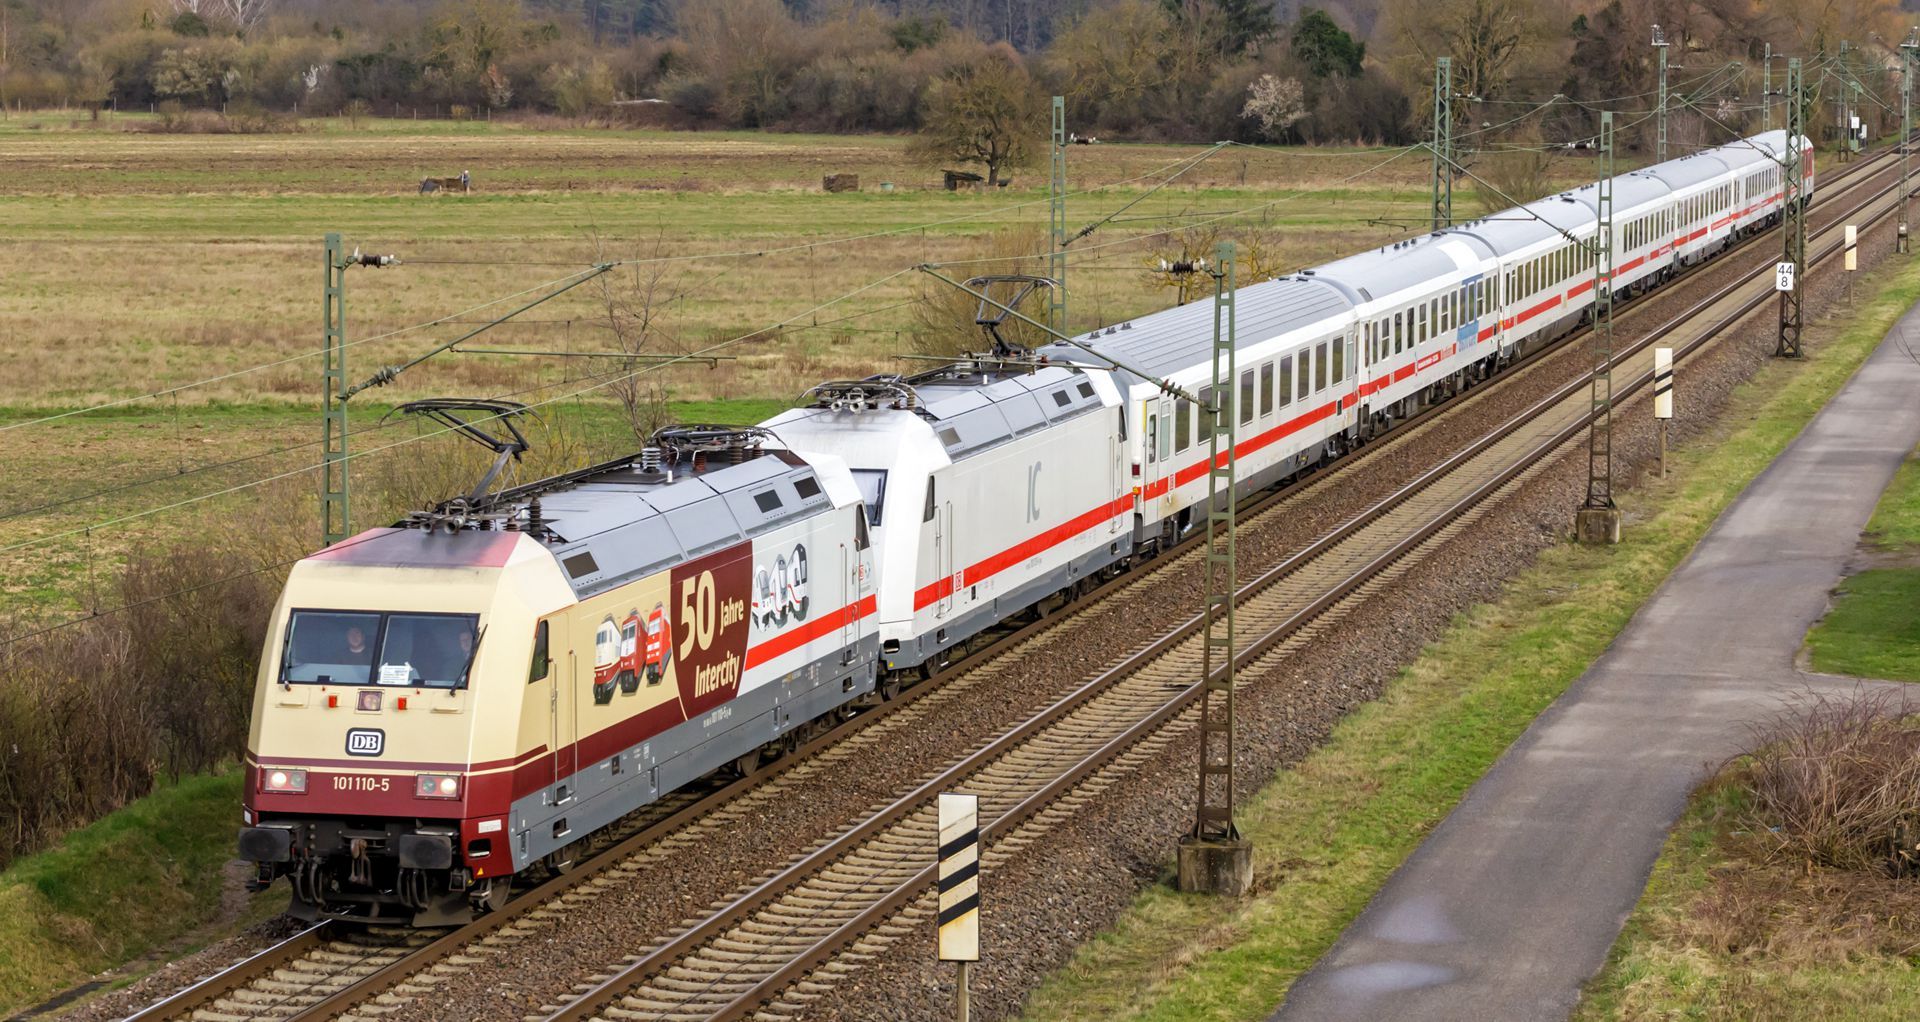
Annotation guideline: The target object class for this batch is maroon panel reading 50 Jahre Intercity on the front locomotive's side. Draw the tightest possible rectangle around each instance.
[668,544,753,720]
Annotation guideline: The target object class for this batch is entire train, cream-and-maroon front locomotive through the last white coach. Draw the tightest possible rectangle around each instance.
[238,131,1812,926]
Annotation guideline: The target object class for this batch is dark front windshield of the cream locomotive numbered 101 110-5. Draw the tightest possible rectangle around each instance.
[280,611,478,688]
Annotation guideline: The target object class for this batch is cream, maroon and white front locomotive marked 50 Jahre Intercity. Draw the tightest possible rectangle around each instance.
[240,418,877,924]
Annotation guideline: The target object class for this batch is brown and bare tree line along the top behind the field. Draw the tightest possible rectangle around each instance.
[0,0,1907,153]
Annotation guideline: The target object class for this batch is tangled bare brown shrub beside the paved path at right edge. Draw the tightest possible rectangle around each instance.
[1734,690,1920,872]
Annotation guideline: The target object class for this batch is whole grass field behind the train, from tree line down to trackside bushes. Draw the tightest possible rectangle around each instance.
[0,113,1482,617]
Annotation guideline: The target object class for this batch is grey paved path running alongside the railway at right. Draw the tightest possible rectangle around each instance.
[1273,309,1920,1022]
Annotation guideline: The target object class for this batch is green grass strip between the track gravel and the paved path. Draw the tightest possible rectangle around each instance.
[1021,203,1920,1022]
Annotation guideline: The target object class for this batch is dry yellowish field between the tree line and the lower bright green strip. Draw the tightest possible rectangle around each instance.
[0,121,1443,407]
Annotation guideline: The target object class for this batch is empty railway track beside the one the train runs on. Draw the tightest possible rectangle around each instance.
[529,159,1920,1022]
